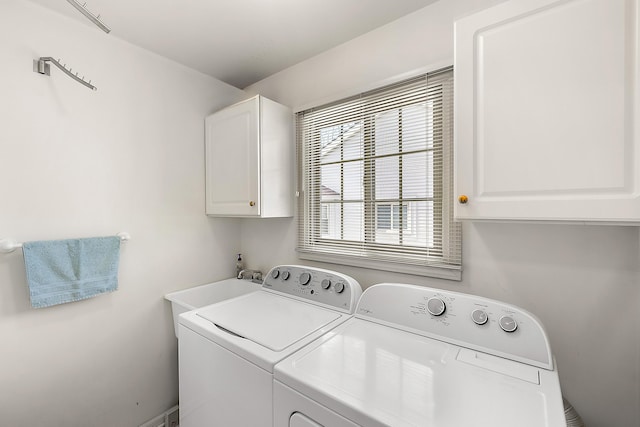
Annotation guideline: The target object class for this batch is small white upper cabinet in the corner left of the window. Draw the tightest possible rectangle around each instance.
[205,95,294,218]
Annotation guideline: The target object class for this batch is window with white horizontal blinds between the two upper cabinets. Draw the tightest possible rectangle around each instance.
[297,69,461,280]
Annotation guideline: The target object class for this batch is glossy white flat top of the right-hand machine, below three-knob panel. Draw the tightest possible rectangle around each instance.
[274,318,564,427]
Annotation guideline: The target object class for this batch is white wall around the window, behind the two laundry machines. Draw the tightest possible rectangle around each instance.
[241,0,640,427]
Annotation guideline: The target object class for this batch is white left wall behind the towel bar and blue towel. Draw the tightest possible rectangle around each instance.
[0,0,245,427]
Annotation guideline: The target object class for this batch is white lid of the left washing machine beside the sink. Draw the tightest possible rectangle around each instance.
[198,291,341,351]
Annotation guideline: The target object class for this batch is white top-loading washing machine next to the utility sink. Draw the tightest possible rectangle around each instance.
[178,265,362,427]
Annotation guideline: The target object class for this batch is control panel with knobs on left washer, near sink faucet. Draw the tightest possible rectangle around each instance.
[262,265,362,314]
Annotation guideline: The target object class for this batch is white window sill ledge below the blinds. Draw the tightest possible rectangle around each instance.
[298,250,462,282]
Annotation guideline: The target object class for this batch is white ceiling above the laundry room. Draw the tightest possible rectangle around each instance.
[31,0,436,89]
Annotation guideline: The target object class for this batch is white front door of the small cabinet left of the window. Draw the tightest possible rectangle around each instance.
[205,97,260,216]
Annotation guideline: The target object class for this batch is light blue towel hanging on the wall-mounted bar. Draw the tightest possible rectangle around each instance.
[22,236,120,308]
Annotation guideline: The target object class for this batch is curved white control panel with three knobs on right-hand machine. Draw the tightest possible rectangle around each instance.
[356,283,553,369]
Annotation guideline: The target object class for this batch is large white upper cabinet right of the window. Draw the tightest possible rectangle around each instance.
[454,0,640,223]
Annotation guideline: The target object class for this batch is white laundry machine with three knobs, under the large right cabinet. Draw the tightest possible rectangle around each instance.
[274,284,566,427]
